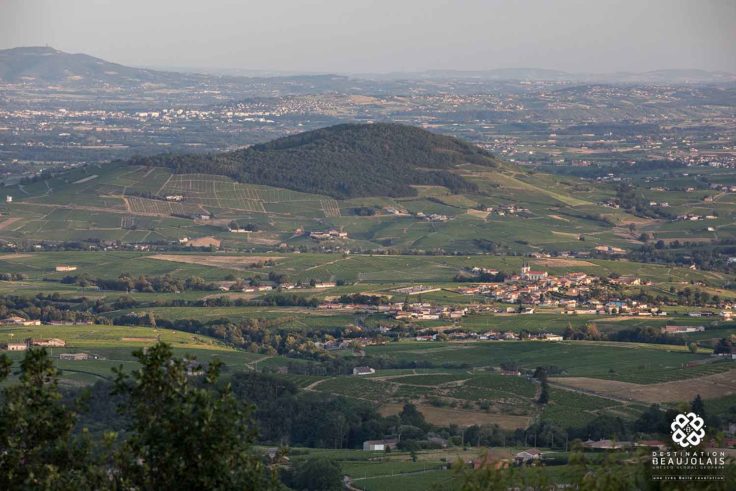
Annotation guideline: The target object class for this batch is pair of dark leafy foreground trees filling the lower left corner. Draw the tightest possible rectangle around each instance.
[0,344,278,490]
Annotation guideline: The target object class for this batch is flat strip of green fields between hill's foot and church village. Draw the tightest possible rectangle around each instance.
[0,251,728,288]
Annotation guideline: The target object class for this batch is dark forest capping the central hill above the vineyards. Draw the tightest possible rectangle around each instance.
[129,123,498,198]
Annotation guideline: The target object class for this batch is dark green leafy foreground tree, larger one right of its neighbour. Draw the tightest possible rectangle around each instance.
[115,343,274,490]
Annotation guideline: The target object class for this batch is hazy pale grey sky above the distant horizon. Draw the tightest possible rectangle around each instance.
[0,0,736,73]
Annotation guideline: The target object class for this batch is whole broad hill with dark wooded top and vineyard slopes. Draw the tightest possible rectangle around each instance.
[7,124,712,253]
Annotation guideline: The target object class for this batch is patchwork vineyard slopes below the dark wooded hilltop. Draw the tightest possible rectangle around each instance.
[0,158,736,258]
